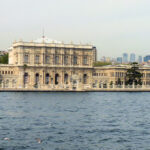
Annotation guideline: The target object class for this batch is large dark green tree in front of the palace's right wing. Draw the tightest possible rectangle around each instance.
[125,62,142,85]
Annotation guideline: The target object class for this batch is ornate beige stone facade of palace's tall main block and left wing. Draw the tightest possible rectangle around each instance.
[0,38,96,89]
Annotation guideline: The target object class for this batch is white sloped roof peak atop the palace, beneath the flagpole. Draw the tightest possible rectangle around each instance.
[34,37,62,44]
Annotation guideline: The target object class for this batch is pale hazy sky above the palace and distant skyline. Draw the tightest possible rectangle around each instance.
[0,0,150,57]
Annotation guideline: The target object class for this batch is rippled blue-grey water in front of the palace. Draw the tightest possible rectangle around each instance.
[0,92,150,150]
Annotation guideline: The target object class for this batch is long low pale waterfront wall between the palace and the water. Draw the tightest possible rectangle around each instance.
[0,85,150,92]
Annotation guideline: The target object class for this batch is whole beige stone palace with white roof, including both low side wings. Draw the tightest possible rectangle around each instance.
[0,37,150,91]
